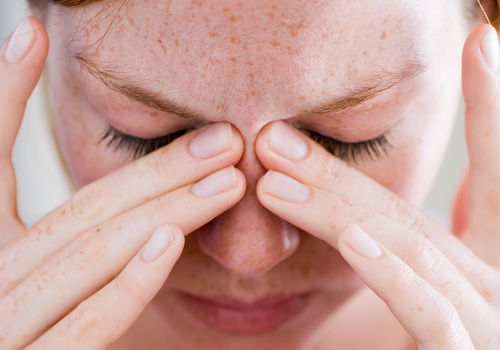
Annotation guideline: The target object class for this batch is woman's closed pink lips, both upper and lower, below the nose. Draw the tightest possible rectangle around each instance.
[179,293,311,334]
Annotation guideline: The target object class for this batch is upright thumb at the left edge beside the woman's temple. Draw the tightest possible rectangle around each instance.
[0,17,48,219]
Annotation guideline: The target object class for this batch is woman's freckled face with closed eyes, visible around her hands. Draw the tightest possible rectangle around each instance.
[43,0,467,349]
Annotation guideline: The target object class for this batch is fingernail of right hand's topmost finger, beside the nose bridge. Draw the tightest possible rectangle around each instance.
[269,122,307,160]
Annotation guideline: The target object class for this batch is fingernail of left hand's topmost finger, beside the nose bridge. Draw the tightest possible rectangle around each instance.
[189,123,232,158]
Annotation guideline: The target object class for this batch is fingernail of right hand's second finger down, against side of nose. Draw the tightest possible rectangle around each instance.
[263,171,310,203]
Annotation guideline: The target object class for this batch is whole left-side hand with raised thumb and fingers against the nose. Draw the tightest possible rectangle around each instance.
[0,18,245,349]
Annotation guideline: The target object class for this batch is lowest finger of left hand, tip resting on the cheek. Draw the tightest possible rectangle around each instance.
[26,225,184,350]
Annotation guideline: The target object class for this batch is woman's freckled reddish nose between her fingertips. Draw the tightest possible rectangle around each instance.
[198,127,300,277]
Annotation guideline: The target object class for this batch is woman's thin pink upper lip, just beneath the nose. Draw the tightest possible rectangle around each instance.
[180,292,310,310]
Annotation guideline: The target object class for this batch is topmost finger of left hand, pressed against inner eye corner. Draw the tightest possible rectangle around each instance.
[0,123,243,294]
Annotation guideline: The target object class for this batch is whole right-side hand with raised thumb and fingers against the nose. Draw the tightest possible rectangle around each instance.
[256,25,500,350]
